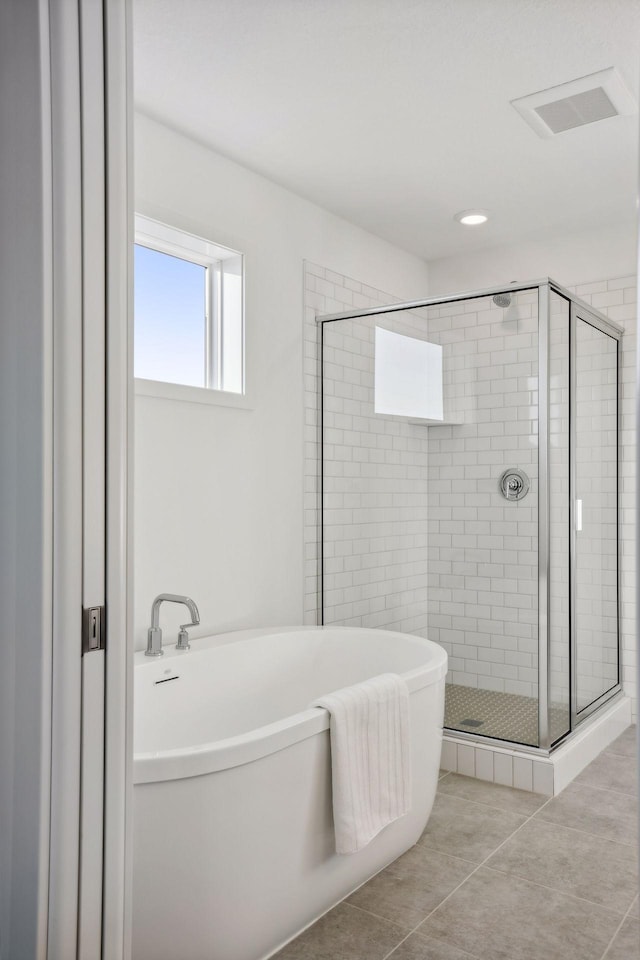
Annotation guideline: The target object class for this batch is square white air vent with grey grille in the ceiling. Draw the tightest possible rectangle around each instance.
[511,67,636,138]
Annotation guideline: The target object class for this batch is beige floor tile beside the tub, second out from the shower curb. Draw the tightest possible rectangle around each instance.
[418,796,526,863]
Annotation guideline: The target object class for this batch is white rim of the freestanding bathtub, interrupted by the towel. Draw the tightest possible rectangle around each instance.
[133,626,447,785]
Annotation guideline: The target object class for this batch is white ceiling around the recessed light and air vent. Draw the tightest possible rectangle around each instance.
[133,0,640,260]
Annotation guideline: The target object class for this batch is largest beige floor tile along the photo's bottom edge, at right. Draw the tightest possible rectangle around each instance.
[418,867,620,960]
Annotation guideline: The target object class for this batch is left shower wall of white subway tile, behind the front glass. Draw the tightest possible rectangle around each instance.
[323,292,429,636]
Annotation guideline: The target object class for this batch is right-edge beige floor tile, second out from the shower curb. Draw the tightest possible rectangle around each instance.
[536,783,638,844]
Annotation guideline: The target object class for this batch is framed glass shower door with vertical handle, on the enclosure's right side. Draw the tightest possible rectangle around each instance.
[573,310,619,719]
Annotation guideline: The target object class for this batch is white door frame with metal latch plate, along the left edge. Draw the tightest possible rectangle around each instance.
[0,0,131,960]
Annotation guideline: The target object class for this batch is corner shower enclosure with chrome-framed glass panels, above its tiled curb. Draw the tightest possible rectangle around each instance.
[318,279,621,750]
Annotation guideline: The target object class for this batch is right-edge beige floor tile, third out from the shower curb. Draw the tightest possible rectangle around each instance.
[487,819,638,914]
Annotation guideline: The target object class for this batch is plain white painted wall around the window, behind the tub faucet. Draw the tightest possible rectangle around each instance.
[134,115,428,647]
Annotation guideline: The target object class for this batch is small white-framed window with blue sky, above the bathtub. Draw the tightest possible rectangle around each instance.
[134,216,244,394]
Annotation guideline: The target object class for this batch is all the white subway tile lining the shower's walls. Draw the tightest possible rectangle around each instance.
[305,263,636,728]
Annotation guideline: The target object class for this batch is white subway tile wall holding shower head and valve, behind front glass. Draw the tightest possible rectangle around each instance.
[427,290,538,698]
